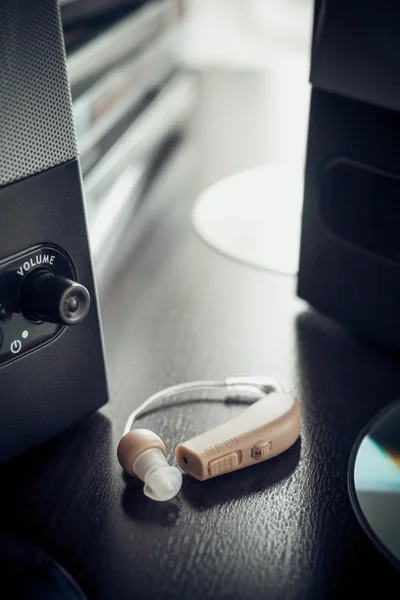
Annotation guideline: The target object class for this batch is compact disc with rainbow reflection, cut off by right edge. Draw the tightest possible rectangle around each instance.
[348,401,400,568]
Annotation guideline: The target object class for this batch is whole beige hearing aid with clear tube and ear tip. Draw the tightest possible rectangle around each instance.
[118,377,301,500]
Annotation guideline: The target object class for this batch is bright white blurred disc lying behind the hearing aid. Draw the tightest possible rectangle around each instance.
[192,164,303,274]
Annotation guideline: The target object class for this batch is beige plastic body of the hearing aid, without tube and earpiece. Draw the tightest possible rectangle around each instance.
[176,392,301,481]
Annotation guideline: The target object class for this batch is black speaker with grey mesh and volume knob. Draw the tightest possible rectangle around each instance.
[0,0,107,461]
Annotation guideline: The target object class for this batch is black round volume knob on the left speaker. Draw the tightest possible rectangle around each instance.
[20,269,90,325]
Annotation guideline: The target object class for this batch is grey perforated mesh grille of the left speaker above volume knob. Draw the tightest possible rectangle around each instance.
[0,0,78,186]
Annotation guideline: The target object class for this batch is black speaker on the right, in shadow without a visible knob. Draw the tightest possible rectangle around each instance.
[298,0,400,347]
